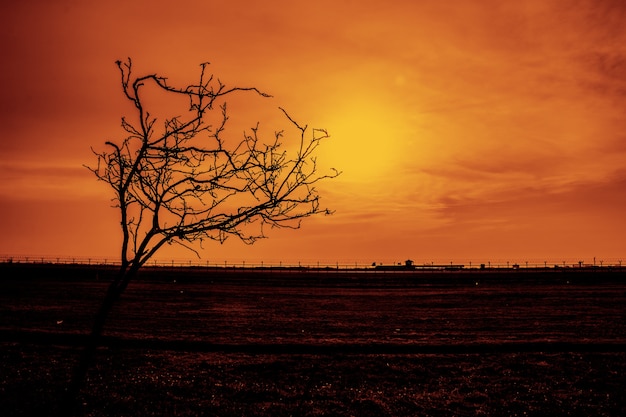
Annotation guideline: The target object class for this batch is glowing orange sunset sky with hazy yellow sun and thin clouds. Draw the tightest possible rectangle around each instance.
[0,0,626,264]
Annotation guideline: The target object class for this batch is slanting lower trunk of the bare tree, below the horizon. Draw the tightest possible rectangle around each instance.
[58,277,129,417]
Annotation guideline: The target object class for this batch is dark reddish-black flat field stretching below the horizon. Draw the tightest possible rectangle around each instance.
[0,264,626,416]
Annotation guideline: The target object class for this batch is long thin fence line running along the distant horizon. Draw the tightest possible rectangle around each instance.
[0,255,626,272]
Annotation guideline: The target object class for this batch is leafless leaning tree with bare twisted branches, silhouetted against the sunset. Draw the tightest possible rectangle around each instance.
[59,59,339,412]
